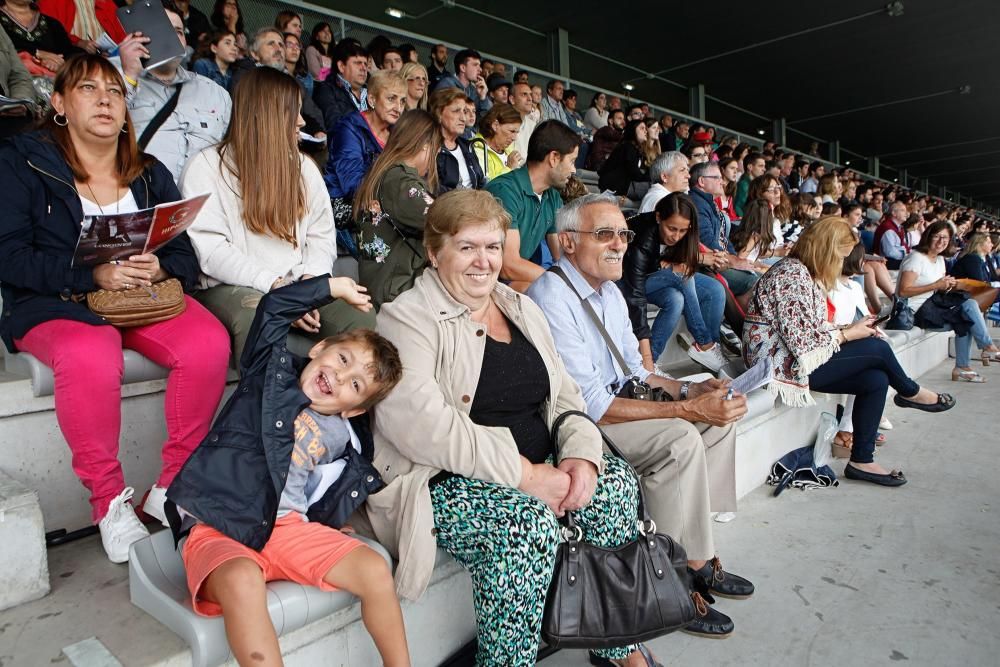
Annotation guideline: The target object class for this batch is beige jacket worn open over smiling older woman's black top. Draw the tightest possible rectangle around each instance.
[367,269,603,600]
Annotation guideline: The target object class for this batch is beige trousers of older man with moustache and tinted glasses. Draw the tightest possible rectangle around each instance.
[602,419,736,560]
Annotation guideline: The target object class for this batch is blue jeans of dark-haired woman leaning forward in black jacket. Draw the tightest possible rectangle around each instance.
[646,269,726,359]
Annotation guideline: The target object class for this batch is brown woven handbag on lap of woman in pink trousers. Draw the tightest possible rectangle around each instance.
[87,278,185,327]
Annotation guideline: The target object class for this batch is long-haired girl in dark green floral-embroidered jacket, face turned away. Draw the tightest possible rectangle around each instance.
[354,109,441,307]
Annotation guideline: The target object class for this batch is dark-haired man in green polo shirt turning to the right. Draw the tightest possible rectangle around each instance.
[486,120,580,292]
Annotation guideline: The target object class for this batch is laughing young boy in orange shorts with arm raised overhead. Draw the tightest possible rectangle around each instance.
[166,276,410,667]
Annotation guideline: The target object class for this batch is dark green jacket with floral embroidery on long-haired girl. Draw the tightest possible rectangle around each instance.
[357,164,434,308]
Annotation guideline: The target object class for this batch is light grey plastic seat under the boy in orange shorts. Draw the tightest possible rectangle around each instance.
[129,530,392,667]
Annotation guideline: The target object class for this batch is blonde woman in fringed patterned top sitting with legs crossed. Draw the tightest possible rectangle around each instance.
[743,217,955,486]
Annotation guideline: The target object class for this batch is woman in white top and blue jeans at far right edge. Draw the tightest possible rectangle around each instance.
[896,220,1000,383]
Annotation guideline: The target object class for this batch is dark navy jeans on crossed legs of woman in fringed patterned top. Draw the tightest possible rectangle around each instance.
[809,338,920,463]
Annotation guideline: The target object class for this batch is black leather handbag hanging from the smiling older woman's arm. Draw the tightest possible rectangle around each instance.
[542,410,695,649]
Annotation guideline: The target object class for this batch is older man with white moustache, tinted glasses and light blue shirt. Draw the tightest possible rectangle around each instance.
[527,194,754,638]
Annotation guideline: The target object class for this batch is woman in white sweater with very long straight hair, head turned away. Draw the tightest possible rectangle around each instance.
[181,67,374,366]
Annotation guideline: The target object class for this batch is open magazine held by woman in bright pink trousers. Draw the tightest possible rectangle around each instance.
[72,194,210,267]
